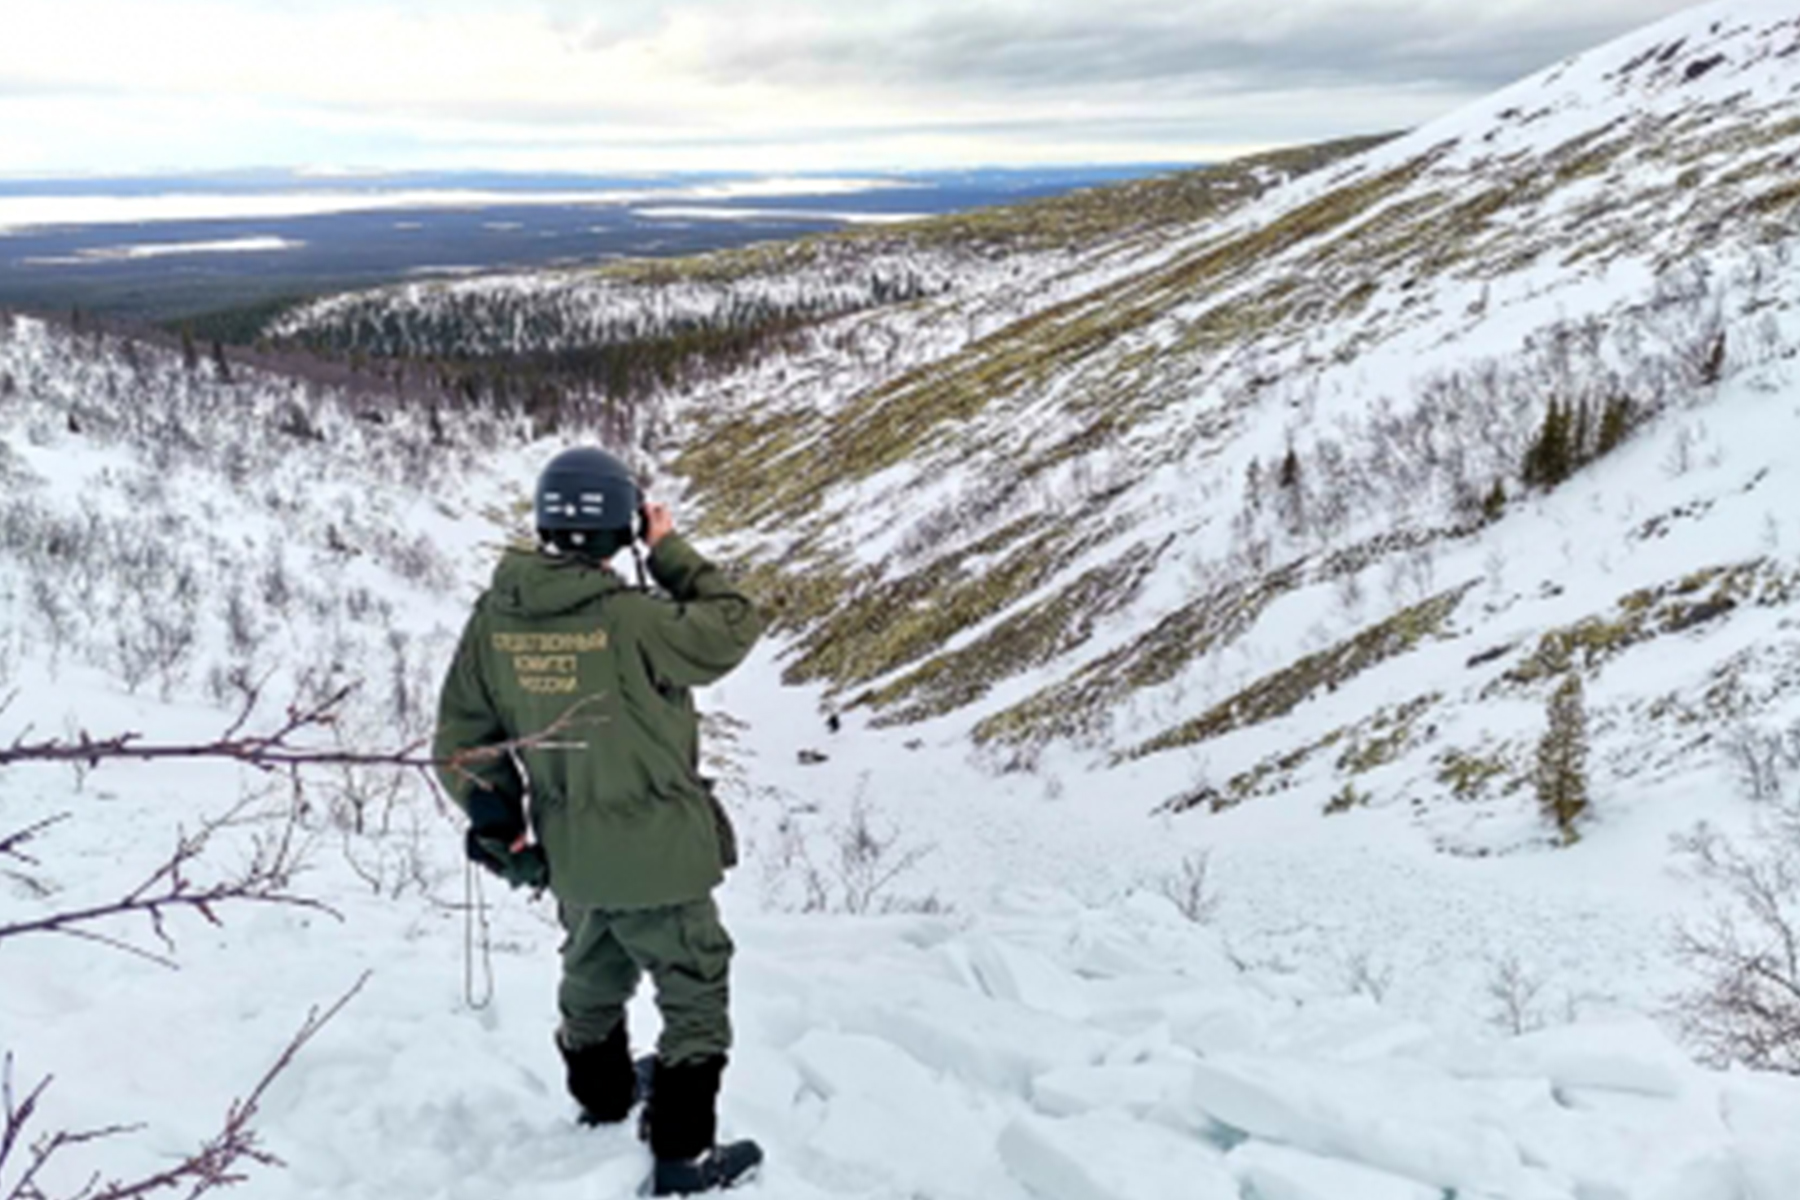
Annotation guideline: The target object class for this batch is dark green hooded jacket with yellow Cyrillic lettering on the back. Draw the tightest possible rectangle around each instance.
[432,534,761,909]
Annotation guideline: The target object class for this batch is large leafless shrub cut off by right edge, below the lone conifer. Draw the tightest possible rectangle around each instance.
[1674,804,1800,1074]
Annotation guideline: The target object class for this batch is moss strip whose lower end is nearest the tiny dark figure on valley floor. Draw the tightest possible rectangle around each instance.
[853,540,1172,725]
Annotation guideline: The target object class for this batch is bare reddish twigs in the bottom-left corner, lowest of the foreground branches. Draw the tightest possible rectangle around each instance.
[0,972,369,1200]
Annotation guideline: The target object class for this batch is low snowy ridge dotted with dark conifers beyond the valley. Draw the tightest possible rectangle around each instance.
[266,139,1381,372]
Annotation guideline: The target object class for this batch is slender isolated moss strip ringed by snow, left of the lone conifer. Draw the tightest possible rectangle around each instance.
[1120,583,1474,759]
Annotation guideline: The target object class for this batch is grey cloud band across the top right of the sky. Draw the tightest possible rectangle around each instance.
[676,0,1688,94]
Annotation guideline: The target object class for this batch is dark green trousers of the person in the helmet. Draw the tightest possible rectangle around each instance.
[556,896,733,1063]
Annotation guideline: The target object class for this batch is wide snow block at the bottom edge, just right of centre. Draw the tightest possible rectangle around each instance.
[999,1112,1238,1200]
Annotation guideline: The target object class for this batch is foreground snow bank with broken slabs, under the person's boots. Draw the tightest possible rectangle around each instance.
[14,770,1800,1200]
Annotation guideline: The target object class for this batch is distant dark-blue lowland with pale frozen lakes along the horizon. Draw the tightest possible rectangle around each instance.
[0,164,1209,323]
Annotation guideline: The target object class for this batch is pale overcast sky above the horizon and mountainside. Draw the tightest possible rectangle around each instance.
[0,0,1688,175]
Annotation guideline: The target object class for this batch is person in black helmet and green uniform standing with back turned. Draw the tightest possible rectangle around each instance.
[432,448,761,1195]
